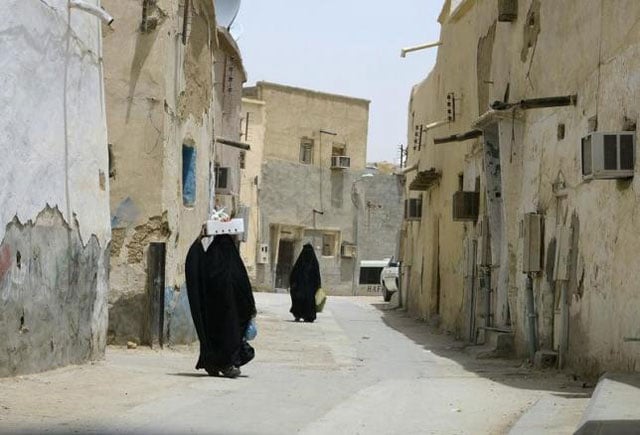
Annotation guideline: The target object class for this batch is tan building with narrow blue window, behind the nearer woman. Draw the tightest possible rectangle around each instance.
[104,0,244,344]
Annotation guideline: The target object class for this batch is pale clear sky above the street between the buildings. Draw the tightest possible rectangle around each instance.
[232,0,443,163]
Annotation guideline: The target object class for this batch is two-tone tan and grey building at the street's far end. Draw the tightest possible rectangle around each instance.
[243,82,401,294]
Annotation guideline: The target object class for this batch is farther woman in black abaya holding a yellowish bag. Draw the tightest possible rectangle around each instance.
[289,243,321,322]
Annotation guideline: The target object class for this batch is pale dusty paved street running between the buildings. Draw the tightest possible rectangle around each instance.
[0,293,590,434]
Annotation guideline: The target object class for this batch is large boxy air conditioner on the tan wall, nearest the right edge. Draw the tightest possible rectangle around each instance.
[582,131,636,179]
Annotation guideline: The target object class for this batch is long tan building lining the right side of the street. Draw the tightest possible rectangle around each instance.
[402,0,640,375]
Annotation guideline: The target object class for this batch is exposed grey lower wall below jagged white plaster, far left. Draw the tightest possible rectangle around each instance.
[0,208,109,376]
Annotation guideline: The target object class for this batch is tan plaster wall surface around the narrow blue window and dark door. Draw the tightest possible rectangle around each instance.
[105,0,217,343]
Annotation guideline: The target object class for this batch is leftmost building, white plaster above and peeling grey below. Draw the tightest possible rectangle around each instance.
[0,0,111,376]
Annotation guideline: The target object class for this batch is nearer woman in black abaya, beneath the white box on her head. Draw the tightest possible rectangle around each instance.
[185,235,256,377]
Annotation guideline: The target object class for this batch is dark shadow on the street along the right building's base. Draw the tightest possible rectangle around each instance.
[371,302,593,398]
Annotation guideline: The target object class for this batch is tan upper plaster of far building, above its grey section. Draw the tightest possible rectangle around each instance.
[251,82,369,170]
